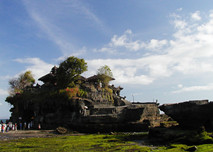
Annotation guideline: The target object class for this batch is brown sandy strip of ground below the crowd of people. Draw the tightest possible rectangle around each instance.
[0,130,56,140]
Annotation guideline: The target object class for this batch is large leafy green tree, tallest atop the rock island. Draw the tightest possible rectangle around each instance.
[56,56,87,88]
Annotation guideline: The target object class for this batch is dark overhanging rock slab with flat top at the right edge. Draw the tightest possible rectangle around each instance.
[159,100,213,129]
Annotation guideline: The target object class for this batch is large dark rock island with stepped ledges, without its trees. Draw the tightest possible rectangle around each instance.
[6,67,160,132]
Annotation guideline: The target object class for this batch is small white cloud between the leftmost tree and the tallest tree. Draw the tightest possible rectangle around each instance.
[15,58,54,80]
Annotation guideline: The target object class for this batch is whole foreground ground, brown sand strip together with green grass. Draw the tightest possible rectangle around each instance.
[0,130,213,152]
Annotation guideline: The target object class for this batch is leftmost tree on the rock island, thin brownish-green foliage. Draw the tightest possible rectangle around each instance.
[9,71,35,95]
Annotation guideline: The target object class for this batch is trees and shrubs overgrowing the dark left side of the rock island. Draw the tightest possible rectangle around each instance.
[6,56,114,126]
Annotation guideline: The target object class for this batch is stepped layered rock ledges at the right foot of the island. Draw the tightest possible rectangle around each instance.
[70,103,160,132]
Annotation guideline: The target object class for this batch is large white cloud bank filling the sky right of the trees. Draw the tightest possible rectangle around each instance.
[90,12,213,86]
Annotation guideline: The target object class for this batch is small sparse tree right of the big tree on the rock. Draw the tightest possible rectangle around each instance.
[97,65,113,87]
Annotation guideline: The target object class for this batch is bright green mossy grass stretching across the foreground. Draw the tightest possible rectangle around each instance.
[0,134,213,152]
